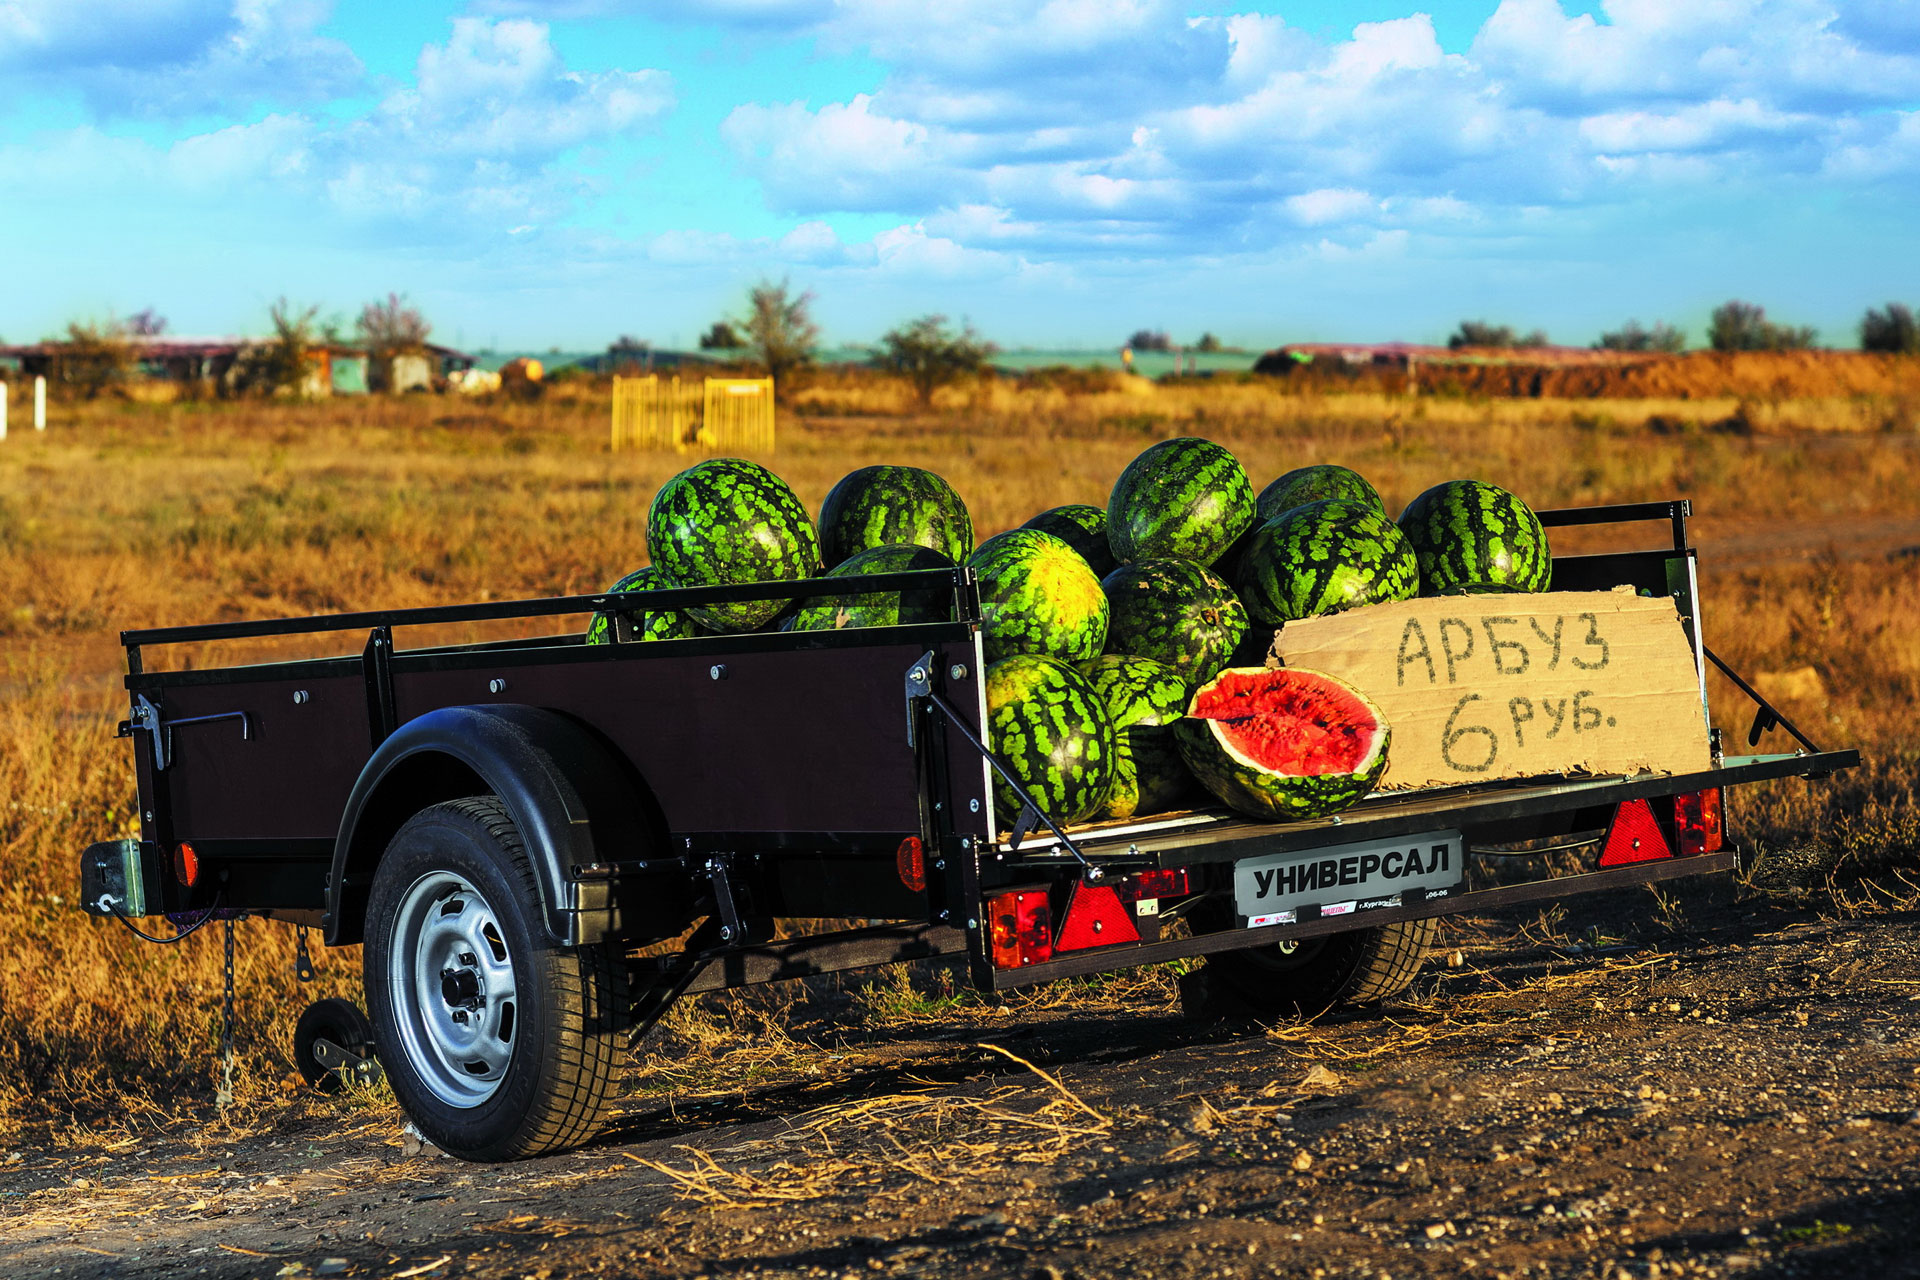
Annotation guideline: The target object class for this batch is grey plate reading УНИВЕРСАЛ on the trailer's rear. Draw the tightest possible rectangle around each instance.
[1233,831,1467,925]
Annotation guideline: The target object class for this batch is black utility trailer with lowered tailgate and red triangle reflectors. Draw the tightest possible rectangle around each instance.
[81,501,1859,1159]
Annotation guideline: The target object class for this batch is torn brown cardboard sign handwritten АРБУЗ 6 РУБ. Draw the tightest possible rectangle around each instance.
[1269,587,1711,791]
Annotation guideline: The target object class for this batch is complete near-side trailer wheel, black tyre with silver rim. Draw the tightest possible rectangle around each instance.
[365,796,626,1161]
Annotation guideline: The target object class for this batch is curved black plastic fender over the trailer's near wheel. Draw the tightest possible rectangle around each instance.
[323,704,685,946]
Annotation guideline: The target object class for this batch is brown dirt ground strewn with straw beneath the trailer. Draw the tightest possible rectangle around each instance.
[0,881,1920,1280]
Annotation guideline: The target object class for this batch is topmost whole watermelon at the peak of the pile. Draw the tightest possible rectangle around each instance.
[1106,436,1254,564]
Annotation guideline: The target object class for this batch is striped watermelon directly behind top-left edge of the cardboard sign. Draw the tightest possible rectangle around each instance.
[1235,497,1421,626]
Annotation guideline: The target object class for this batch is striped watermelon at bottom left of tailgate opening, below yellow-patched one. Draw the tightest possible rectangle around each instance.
[987,652,1114,829]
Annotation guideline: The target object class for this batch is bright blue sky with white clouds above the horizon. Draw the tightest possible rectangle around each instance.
[0,0,1920,349]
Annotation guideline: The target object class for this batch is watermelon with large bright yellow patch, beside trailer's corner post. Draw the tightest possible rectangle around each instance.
[968,530,1106,662]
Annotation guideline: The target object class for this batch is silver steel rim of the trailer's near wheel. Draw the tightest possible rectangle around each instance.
[388,871,520,1107]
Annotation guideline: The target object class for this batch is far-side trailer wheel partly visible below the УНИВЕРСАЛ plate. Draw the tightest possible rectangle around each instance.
[1202,919,1438,1017]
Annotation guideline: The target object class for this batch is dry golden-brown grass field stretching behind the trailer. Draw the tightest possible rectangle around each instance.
[0,378,1920,1146]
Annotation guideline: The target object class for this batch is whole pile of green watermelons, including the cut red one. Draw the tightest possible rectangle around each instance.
[586,438,1553,829]
